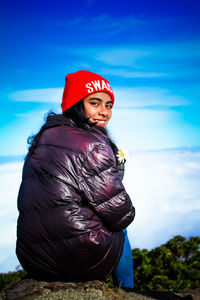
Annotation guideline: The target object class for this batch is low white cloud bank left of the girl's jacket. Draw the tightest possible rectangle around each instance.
[0,162,23,272]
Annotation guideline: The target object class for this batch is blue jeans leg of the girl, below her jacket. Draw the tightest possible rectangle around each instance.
[112,229,134,288]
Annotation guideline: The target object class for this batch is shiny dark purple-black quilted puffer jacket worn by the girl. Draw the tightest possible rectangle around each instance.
[16,116,134,281]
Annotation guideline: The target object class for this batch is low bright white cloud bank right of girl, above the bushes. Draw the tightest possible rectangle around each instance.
[124,150,200,249]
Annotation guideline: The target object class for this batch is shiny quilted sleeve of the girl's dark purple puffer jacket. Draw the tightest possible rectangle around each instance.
[81,143,135,231]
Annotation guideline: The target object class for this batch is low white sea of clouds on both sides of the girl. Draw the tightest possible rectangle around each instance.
[0,149,200,272]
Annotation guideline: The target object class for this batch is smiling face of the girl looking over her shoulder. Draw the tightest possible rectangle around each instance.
[83,92,112,127]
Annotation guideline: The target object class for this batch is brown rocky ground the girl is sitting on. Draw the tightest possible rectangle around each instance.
[0,279,200,300]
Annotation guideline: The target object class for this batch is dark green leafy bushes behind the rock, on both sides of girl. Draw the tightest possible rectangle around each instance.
[0,235,200,292]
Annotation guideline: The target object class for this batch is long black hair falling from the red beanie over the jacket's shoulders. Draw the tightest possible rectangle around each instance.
[27,100,118,155]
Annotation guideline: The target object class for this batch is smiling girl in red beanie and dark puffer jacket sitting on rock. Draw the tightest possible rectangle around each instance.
[16,71,135,287]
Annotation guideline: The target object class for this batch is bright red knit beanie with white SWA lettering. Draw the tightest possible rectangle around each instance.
[61,71,114,112]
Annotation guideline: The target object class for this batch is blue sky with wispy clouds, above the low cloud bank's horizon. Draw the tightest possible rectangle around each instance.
[0,0,200,155]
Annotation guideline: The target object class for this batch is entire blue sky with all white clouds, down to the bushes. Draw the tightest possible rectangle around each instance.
[0,0,200,271]
